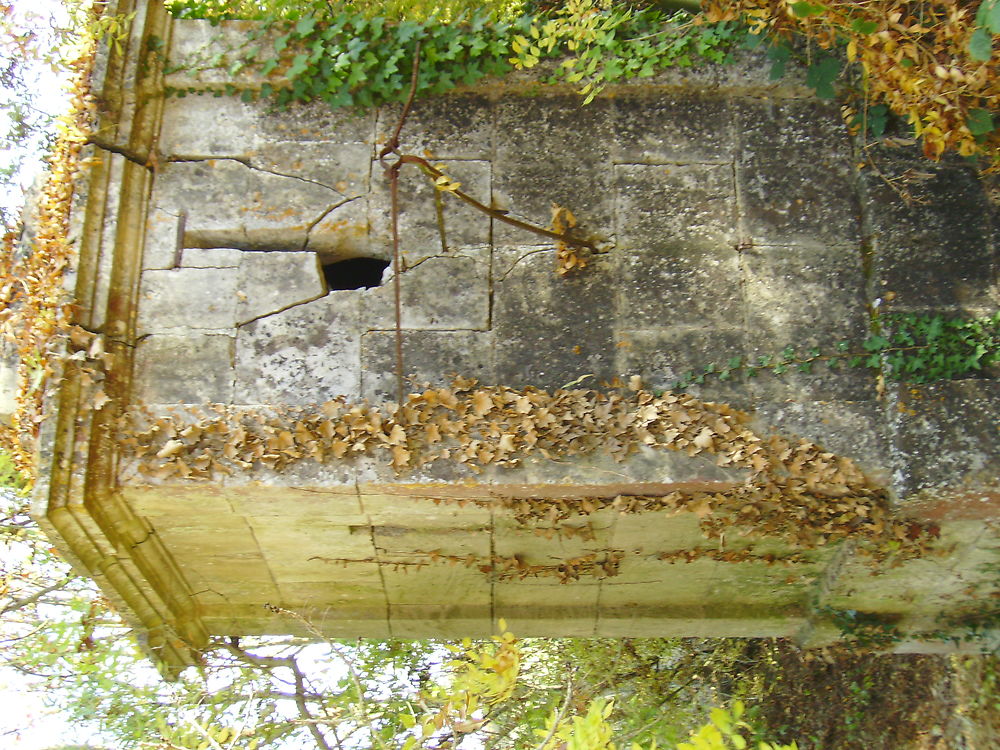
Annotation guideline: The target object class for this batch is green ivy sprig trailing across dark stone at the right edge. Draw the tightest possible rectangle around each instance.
[673,312,1000,391]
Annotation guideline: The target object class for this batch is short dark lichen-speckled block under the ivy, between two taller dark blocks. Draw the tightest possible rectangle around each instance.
[611,94,735,164]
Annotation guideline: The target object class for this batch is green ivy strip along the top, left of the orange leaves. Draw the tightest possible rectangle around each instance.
[164,0,739,107]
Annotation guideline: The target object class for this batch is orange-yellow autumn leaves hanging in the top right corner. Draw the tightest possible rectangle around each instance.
[705,0,1000,168]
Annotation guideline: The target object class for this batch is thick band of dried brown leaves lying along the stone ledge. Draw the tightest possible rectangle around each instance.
[120,379,937,562]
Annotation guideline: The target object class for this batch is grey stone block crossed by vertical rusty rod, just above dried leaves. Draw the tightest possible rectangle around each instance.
[361,331,496,403]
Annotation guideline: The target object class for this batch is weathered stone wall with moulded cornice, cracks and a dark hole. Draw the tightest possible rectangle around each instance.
[27,0,1000,676]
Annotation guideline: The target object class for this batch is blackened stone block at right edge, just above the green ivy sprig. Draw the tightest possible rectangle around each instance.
[864,164,1000,311]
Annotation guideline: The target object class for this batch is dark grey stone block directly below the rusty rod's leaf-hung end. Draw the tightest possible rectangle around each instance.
[493,249,617,388]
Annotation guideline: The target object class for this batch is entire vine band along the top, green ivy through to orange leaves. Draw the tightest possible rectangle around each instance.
[166,0,1000,166]
